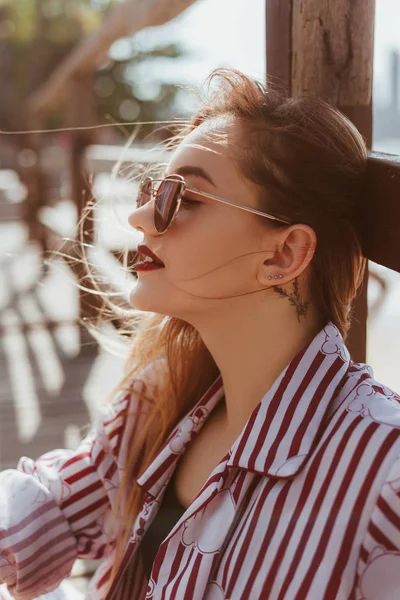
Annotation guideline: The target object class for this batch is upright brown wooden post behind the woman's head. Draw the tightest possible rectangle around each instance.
[266,0,375,362]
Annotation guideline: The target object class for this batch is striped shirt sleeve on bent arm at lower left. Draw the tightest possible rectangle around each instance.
[0,372,153,600]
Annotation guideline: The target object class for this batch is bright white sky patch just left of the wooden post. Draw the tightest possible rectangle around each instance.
[111,0,266,105]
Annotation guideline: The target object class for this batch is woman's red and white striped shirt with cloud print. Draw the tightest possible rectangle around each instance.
[0,324,400,600]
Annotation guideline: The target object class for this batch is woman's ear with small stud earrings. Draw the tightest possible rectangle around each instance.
[258,224,317,286]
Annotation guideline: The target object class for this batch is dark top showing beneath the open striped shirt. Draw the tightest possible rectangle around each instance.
[140,476,186,580]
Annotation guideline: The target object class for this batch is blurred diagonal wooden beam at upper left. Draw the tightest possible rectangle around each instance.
[28,0,196,114]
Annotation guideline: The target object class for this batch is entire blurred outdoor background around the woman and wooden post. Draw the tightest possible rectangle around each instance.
[0,0,400,575]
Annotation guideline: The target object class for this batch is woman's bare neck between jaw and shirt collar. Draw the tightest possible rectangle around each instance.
[192,302,325,436]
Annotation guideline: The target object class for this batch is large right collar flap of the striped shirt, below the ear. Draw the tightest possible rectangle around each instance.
[228,323,350,478]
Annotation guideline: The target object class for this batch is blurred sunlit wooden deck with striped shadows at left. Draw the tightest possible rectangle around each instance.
[0,222,123,591]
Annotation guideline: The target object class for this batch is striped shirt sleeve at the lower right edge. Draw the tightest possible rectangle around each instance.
[357,458,400,600]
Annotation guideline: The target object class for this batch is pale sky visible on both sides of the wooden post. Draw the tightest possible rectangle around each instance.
[122,0,400,112]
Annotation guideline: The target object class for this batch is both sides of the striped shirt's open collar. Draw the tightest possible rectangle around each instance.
[137,323,350,497]
